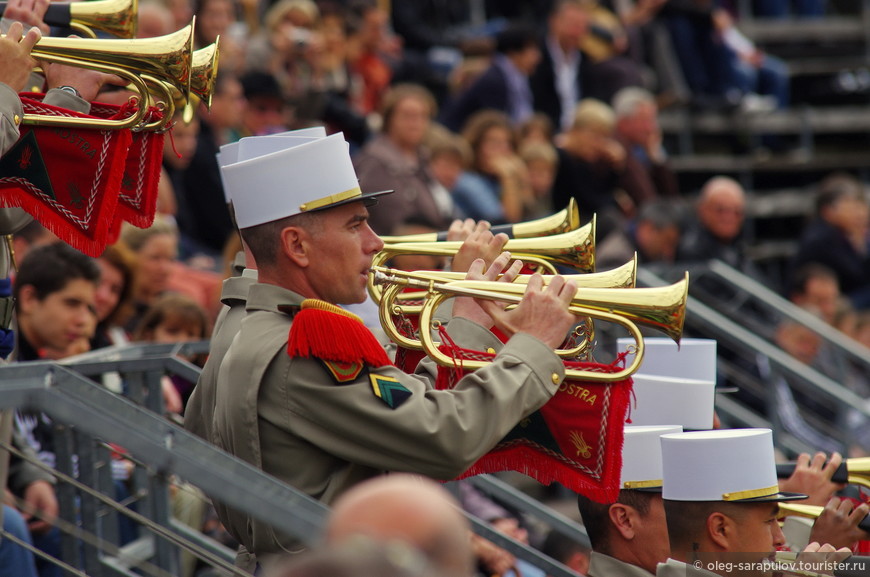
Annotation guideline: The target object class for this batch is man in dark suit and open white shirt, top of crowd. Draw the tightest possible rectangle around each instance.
[530,0,641,130]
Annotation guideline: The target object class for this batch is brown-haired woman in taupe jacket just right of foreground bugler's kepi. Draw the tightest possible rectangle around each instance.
[354,84,453,234]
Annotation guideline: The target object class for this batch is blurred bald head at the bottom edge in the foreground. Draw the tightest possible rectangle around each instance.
[326,474,472,576]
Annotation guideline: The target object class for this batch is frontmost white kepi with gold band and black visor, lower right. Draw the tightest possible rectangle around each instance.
[661,429,806,502]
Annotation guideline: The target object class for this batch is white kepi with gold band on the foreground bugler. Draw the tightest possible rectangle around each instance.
[221,133,392,228]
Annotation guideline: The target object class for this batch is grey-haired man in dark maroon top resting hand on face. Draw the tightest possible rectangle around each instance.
[613,87,679,206]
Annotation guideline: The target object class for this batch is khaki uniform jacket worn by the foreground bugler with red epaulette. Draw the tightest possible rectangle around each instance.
[214,284,564,559]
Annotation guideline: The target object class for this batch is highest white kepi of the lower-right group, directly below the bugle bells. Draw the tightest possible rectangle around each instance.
[617,337,716,383]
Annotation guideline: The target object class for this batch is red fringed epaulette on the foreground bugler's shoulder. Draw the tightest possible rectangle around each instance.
[287,299,392,367]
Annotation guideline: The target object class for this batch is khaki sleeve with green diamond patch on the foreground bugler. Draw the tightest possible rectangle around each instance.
[259,321,564,480]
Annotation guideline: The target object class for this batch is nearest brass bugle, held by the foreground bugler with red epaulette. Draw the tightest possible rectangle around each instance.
[371,269,689,382]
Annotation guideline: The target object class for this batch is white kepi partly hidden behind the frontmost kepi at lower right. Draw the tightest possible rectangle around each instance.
[619,425,683,491]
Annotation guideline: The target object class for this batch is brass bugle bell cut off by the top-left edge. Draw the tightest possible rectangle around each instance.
[0,0,138,38]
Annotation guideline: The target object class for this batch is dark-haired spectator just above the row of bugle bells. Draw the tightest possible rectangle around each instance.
[595,200,682,270]
